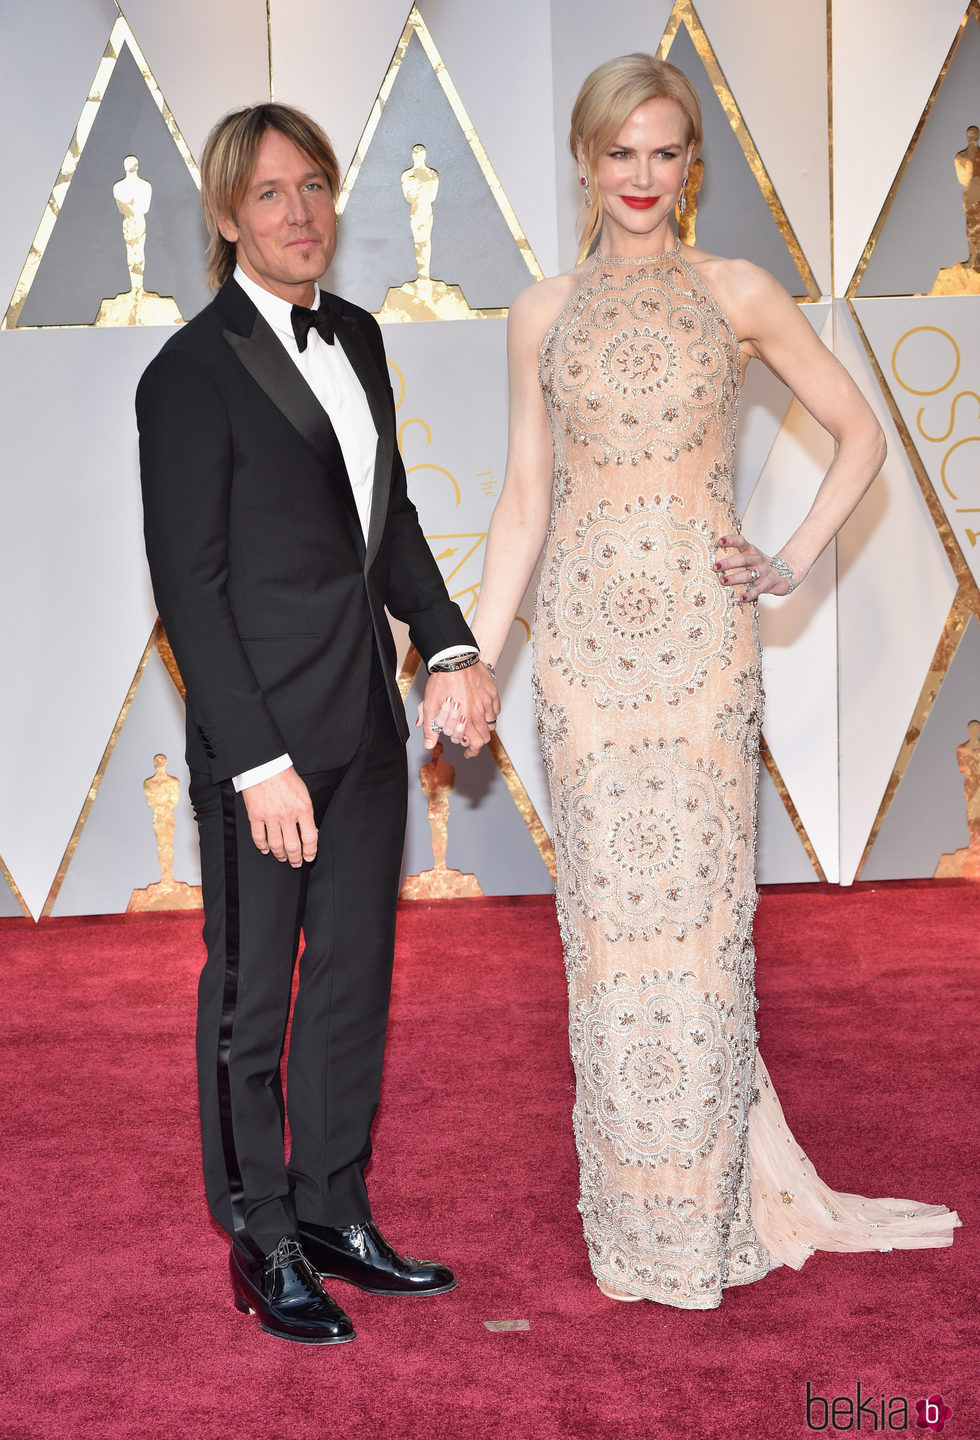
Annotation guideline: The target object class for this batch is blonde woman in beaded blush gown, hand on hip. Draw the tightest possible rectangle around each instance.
[442,55,958,1309]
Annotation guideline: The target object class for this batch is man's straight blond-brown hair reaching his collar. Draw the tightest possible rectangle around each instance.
[201,102,340,289]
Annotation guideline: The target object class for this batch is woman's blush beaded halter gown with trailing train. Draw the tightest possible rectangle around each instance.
[534,245,958,1309]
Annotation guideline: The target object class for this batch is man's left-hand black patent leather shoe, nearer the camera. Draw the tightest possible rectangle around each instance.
[229,1237,354,1345]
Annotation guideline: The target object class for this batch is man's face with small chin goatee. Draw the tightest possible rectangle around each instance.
[219,130,337,305]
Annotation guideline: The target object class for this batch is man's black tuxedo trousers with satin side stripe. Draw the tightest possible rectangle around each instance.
[190,687,406,1254]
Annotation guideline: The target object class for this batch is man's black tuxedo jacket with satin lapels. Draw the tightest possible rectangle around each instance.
[137,279,473,782]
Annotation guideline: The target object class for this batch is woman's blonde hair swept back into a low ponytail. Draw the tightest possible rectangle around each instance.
[568,50,704,255]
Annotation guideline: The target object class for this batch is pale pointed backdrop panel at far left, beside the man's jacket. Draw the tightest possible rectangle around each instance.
[0,328,165,914]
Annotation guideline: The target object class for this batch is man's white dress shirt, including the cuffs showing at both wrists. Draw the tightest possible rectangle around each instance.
[232,265,473,791]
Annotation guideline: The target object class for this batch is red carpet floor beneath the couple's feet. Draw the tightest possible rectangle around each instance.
[0,881,980,1440]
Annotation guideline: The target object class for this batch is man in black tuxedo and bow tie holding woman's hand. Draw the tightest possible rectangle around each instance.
[137,104,499,1344]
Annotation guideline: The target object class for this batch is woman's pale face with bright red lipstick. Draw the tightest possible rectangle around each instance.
[596,98,694,253]
